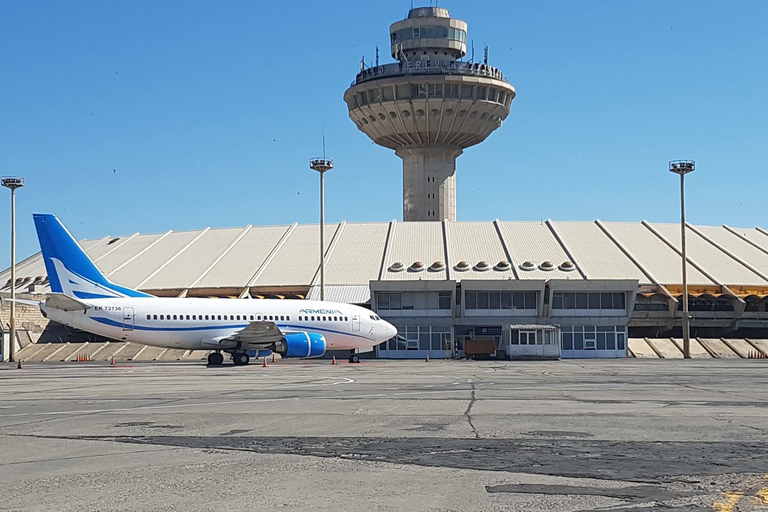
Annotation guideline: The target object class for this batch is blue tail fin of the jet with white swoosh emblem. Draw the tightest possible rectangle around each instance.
[32,213,150,299]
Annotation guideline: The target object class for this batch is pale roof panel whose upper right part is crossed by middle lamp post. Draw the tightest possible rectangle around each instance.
[255,224,339,286]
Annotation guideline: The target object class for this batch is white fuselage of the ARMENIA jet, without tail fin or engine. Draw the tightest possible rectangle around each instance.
[42,297,388,352]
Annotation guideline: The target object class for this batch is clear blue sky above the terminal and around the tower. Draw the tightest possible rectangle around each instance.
[0,0,768,268]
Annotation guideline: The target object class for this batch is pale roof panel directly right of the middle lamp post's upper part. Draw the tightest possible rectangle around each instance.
[314,222,389,286]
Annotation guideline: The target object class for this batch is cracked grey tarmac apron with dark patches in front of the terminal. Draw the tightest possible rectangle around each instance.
[0,359,768,512]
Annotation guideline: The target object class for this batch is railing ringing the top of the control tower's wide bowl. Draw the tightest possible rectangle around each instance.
[350,60,507,87]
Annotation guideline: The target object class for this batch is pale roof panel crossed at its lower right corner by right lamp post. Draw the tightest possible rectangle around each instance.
[603,222,716,285]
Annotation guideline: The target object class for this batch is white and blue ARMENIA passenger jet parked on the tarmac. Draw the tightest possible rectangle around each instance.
[18,214,397,366]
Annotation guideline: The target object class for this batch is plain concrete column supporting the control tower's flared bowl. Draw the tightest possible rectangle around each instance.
[395,146,462,222]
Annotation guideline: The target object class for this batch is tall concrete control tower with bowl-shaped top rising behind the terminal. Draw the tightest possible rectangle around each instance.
[344,7,515,221]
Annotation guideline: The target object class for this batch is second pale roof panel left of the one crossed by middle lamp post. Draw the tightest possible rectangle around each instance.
[142,228,243,290]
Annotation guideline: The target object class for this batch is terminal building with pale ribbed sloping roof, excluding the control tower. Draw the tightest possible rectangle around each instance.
[0,219,768,359]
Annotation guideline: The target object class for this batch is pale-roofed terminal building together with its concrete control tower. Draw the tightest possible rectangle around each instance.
[0,7,768,358]
